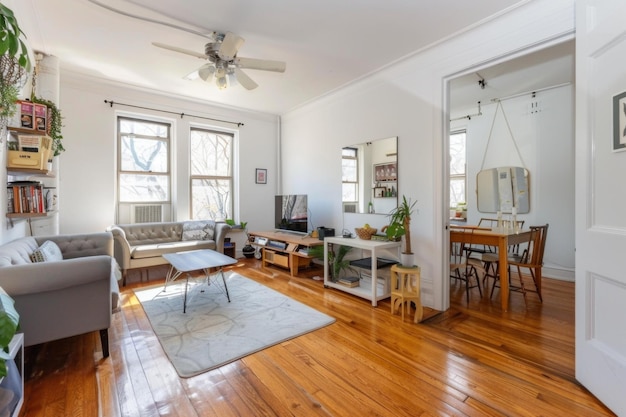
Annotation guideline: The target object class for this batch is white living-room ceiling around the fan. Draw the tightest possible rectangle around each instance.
[12,0,572,114]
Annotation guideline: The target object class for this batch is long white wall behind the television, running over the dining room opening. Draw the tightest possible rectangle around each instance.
[282,0,574,309]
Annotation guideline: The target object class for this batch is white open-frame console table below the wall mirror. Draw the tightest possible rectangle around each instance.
[324,237,400,307]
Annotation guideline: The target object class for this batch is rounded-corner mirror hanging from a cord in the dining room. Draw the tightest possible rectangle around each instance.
[476,167,530,214]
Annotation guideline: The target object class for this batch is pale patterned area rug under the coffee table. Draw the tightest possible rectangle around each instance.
[135,273,335,378]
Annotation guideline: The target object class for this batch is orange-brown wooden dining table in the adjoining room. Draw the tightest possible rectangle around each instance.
[450,225,541,311]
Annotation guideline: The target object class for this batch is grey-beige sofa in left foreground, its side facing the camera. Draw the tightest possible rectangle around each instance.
[0,233,121,357]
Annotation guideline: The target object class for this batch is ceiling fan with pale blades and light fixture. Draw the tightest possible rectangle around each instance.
[152,32,286,90]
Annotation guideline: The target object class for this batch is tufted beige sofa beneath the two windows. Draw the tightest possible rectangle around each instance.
[109,220,230,285]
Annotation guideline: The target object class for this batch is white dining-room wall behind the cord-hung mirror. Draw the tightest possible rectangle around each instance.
[453,86,574,281]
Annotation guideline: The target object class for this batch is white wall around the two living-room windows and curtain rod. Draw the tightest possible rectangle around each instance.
[54,73,278,233]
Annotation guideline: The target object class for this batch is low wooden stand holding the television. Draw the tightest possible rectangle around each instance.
[250,232,324,277]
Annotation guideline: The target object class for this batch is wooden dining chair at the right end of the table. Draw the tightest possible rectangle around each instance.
[490,224,549,302]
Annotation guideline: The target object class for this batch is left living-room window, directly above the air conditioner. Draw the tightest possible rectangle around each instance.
[117,117,171,203]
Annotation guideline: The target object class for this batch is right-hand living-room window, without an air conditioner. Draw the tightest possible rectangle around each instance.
[189,127,234,220]
